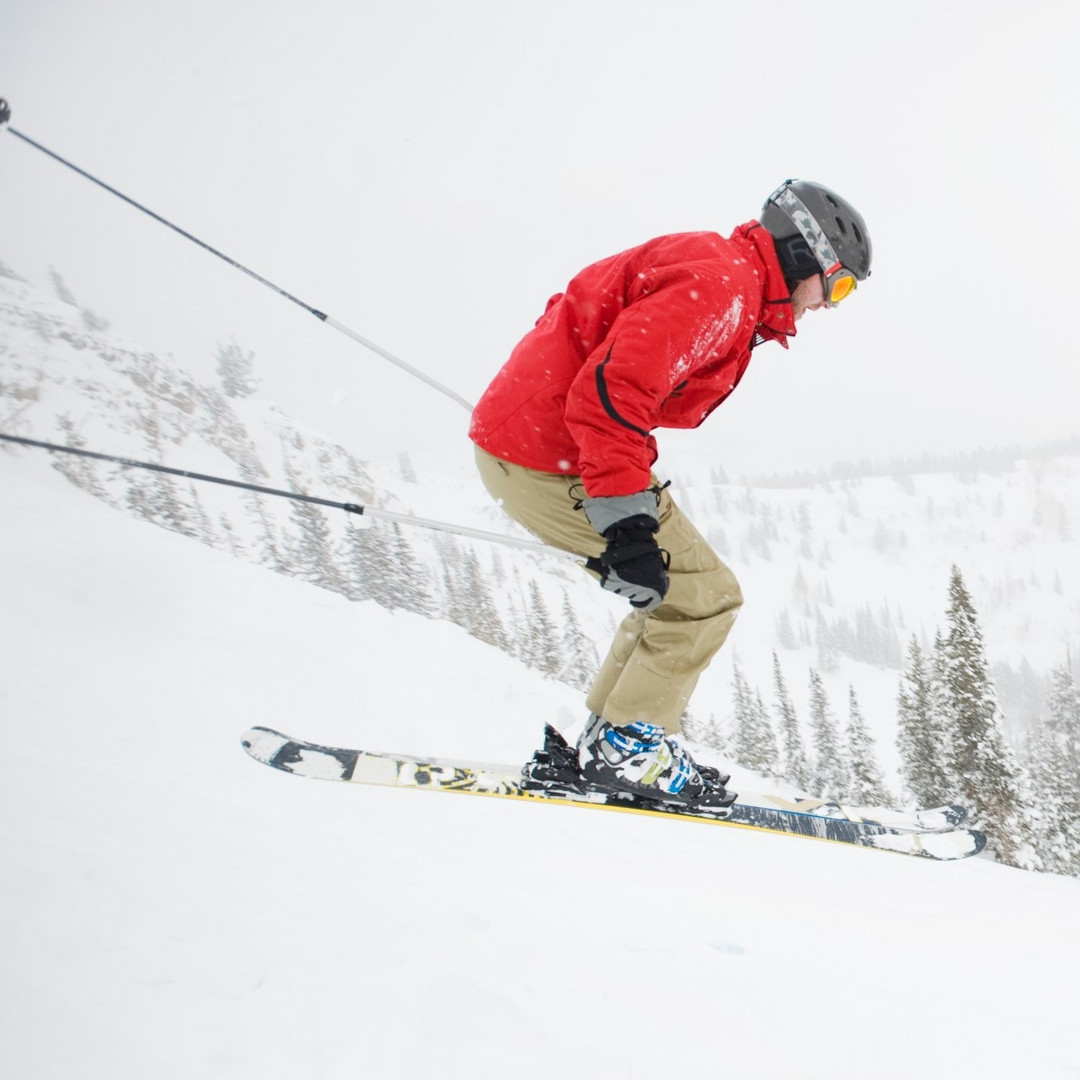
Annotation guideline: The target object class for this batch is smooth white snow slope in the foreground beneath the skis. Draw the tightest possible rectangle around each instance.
[0,451,1080,1080]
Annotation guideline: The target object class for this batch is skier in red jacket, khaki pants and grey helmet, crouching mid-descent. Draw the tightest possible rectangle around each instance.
[469,174,872,805]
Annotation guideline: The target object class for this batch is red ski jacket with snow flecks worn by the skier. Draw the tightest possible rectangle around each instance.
[469,221,795,497]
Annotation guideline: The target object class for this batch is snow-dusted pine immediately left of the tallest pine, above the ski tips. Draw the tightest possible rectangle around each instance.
[896,635,957,807]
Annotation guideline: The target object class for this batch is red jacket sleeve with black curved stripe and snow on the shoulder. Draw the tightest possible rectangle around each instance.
[566,271,744,497]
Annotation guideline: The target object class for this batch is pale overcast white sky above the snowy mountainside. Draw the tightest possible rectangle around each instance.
[0,0,1080,474]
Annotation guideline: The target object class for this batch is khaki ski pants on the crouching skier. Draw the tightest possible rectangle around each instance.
[476,446,742,734]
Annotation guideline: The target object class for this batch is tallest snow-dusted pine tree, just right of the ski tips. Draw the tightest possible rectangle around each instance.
[942,566,1038,869]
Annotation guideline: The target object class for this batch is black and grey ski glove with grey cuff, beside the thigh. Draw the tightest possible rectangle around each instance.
[584,489,670,611]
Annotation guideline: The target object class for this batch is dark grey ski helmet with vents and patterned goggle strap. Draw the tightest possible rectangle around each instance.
[761,180,873,284]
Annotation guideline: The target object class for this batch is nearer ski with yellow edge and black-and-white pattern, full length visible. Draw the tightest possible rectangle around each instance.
[242,726,986,861]
